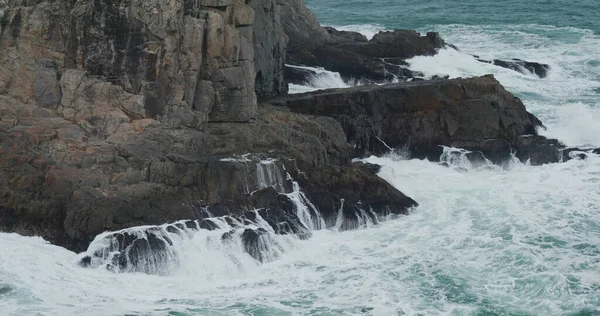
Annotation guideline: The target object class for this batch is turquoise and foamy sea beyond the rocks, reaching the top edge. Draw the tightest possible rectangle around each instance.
[306,0,600,146]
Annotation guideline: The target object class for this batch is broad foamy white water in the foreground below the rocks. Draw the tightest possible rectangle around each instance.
[0,155,600,315]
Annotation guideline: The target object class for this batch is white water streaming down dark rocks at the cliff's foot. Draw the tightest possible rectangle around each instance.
[79,156,387,275]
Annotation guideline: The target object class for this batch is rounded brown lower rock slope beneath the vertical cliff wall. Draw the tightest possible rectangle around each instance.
[0,90,414,251]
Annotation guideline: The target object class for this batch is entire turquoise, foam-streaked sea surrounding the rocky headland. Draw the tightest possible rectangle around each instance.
[0,0,600,316]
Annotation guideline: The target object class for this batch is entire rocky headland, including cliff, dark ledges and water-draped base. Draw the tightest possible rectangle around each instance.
[0,0,581,274]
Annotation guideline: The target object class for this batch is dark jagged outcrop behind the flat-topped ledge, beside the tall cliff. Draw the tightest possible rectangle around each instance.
[282,0,446,83]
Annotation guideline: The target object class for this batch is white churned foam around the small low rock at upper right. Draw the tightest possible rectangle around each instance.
[409,25,600,146]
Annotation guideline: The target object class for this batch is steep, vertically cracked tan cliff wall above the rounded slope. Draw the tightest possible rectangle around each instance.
[0,0,262,125]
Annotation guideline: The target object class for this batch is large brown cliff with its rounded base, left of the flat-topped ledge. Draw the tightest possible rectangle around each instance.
[0,0,416,251]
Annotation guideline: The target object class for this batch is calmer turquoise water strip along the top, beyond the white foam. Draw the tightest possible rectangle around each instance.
[306,0,600,34]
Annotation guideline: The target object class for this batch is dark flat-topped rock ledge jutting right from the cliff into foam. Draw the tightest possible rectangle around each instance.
[271,75,560,164]
